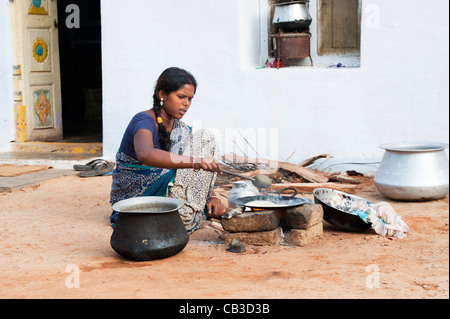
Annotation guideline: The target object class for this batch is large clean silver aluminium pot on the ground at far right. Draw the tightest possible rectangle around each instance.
[374,142,449,201]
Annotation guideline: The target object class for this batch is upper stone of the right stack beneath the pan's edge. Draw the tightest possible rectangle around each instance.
[285,204,323,229]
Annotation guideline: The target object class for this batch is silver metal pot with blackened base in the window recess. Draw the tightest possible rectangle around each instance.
[272,0,312,32]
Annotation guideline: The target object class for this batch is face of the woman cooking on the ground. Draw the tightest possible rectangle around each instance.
[159,84,195,119]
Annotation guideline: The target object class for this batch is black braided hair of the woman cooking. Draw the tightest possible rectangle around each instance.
[153,67,197,151]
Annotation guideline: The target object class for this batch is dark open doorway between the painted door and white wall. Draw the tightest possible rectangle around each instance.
[58,0,102,143]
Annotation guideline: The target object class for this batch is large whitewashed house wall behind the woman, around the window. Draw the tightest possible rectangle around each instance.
[102,0,449,170]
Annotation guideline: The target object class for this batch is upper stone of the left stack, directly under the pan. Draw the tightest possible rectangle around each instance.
[222,210,280,233]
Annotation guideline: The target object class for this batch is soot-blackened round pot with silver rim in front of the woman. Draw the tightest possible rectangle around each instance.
[110,196,189,261]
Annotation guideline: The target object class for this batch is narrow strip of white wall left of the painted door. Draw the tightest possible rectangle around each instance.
[0,0,14,152]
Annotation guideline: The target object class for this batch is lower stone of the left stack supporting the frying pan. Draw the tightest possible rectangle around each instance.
[224,227,283,246]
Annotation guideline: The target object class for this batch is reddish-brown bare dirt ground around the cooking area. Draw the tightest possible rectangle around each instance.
[0,175,449,299]
